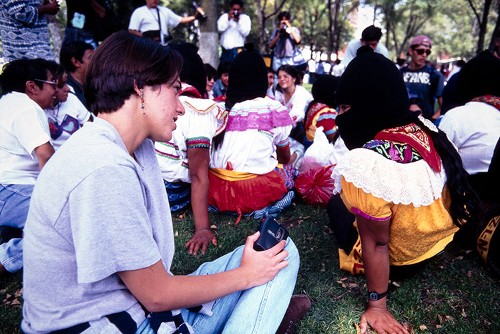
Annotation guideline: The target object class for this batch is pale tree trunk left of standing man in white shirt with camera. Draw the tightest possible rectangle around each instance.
[198,0,219,68]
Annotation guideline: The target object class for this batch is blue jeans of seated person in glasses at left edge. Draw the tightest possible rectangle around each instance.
[0,184,33,273]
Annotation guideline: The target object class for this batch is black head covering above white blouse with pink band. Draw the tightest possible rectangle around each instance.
[226,45,267,105]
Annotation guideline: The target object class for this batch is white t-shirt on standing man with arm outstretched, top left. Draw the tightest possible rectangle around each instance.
[128,6,182,35]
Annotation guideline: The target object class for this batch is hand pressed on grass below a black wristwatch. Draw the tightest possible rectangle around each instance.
[359,306,409,334]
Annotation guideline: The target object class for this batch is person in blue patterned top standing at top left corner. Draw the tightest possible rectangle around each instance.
[0,0,59,62]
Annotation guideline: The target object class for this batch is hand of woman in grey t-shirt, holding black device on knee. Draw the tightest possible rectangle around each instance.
[240,232,288,288]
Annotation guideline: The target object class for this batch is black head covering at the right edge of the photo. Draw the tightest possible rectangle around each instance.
[457,50,500,104]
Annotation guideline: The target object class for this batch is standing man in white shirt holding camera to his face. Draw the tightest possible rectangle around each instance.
[217,0,252,63]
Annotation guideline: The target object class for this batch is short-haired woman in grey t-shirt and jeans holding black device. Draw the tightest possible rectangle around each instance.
[21,32,299,333]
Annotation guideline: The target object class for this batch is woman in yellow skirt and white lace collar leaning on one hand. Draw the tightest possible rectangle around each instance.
[328,46,477,334]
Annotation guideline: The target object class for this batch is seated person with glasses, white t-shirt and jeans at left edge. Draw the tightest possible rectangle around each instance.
[0,58,57,276]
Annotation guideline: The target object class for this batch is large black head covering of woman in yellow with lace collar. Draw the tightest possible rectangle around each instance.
[336,46,418,149]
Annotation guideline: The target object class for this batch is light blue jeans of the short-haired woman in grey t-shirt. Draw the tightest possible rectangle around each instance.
[137,238,300,334]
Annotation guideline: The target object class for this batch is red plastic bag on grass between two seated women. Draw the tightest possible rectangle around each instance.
[295,165,335,207]
